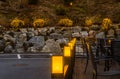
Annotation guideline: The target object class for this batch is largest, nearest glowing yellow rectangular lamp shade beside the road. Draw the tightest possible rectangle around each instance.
[52,56,63,74]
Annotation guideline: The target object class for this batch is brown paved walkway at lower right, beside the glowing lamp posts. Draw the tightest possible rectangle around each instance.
[73,58,120,79]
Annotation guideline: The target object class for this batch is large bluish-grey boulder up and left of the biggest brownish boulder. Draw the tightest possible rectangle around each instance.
[28,36,45,47]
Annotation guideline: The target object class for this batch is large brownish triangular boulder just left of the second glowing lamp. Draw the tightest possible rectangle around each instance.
[41,39,62,54]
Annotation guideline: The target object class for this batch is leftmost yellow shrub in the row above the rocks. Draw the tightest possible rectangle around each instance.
[10,18,25,29]
